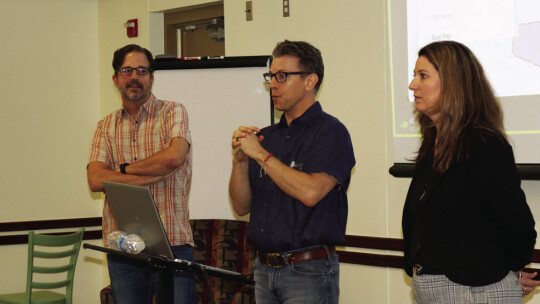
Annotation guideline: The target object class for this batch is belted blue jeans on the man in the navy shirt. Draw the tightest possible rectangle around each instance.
[254,248,339,304]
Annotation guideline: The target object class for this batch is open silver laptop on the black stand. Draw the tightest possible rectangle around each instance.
[103,181,243,276]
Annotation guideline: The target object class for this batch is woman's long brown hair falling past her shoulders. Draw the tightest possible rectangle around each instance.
[416,41,506,174]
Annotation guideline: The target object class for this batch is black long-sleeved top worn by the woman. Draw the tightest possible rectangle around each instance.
[402,129,536,286]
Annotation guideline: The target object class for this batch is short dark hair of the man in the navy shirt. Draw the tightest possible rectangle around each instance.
[272,40,324,94]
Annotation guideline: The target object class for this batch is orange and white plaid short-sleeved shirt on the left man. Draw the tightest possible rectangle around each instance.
[89,94,194,246]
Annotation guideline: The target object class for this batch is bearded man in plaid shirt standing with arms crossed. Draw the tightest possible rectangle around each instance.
[87,44,196,304]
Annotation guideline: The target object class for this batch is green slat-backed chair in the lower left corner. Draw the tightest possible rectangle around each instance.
[0,228,84,304]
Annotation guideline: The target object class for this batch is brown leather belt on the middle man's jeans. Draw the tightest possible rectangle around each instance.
[257,246,336,268]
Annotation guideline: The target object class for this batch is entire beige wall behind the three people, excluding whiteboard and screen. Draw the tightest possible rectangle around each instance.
[0,0,540,304]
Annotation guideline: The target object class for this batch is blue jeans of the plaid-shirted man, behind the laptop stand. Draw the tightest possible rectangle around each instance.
[107,245,197,304]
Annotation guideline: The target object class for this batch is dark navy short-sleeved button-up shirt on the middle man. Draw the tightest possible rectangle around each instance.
[248,102,355,253]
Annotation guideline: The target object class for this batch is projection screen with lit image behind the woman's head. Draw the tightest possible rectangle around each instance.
[389,0,540,164]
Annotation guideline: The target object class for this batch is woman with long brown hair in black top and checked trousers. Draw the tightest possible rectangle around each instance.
[402,41,538,304]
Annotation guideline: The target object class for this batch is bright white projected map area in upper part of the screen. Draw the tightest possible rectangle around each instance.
[407,0,540,100]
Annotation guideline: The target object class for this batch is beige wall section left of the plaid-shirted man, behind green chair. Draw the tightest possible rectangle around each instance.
[0,0,104,303]
